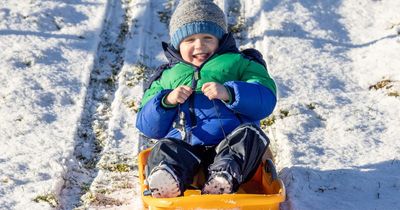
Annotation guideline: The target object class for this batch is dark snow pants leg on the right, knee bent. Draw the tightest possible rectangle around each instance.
[208,124,269,191]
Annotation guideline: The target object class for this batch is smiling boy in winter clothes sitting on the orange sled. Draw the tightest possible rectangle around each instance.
[136,0,276,198]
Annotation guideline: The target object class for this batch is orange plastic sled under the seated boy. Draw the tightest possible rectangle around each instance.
[138,149,286,210]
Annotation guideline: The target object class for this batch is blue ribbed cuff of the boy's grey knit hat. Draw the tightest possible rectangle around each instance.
[171,21,226,50]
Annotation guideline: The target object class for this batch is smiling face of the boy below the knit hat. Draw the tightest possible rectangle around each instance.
[179,34,218,66]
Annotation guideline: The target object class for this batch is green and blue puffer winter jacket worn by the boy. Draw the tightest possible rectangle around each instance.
[136,34,276,145]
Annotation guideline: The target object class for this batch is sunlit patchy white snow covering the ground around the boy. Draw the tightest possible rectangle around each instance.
[0,0,400,209]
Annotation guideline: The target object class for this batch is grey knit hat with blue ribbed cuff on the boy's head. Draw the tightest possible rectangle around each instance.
[169,0,228,49]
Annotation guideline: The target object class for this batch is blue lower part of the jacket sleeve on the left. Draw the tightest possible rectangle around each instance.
[136,90,177,139]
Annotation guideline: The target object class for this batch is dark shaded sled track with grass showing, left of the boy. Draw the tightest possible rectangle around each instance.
[58,0,131,209]
